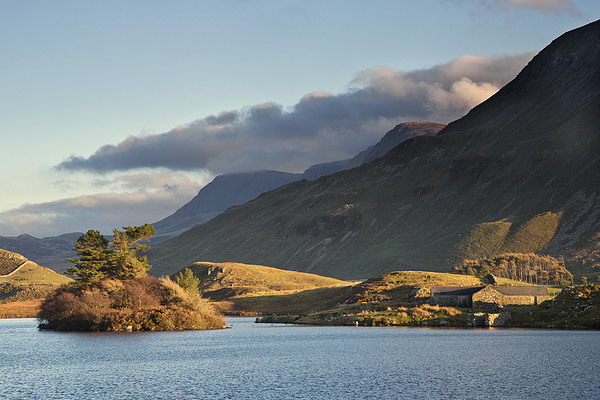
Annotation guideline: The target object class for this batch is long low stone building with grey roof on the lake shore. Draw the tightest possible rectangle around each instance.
[429,285,554,308]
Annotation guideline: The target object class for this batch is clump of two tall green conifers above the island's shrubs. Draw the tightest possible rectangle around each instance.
[68,224,154,285]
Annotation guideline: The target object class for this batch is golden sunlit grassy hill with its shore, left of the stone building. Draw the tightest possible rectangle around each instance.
[189,263,540,326]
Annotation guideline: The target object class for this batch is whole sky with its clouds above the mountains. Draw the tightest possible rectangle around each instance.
[0,0,600,237]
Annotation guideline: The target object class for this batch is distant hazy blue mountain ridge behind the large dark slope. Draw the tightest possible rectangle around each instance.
[152,121,446,243]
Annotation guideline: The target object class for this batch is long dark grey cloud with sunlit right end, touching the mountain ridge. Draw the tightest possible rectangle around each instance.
[57,53,533,174]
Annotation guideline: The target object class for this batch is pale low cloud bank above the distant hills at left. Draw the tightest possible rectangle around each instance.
[0,171,213,237]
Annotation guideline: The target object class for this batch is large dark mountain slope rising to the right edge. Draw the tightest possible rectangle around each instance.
[150,21,600,279]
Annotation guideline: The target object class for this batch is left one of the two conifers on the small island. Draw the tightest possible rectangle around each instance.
[67,229,110,285]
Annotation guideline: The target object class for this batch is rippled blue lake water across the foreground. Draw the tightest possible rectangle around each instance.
[0,318,600,399]
